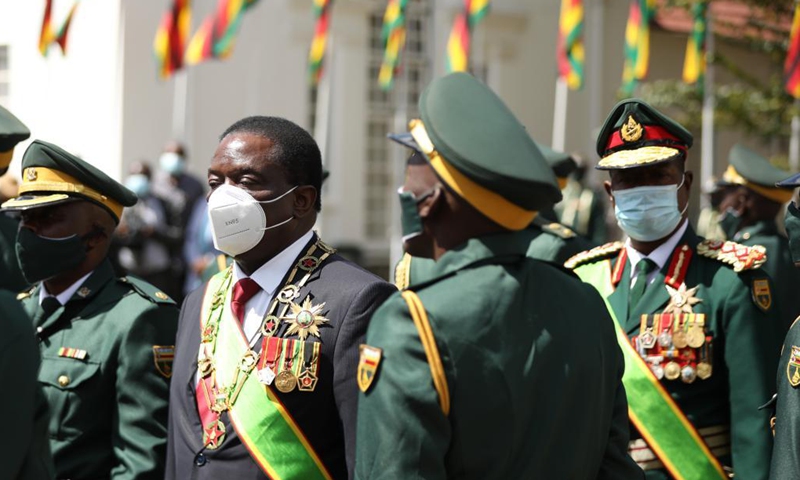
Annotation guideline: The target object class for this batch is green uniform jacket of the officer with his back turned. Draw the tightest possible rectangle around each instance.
[355,231,642,480]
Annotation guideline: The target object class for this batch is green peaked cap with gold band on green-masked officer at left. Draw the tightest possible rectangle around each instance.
[2,140,137,222]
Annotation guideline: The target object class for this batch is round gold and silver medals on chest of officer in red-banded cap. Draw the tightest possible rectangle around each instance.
[636,317,712,383]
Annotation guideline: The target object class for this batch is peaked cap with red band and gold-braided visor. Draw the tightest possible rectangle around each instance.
[596,98,693,170]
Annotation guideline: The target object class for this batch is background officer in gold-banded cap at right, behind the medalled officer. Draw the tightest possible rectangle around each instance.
[720,145,800,330]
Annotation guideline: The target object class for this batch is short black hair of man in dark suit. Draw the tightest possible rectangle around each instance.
[219,116,322,212]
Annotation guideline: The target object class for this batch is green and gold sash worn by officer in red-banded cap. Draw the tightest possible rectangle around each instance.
[575,260,728,480]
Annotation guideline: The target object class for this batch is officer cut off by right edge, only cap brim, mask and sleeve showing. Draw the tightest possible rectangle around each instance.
[769,174,800,480]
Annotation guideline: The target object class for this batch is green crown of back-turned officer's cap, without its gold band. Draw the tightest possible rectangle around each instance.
[419,72,561,210]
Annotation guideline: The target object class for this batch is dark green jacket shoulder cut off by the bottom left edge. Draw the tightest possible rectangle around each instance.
[0,291,55,480]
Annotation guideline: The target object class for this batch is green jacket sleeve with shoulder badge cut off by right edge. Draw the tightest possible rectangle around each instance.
[769,316,800,480]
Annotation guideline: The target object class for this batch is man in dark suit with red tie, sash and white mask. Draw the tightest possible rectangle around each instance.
[166,117,396,480]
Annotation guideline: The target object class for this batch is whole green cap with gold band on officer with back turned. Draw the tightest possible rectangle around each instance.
[389,73,561,230]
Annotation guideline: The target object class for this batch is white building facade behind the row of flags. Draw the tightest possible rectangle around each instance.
[0,0,627,271]
